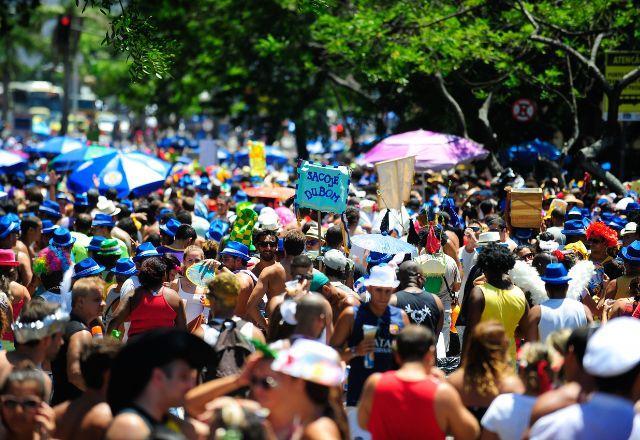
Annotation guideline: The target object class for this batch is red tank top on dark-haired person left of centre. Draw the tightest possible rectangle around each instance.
[129,287,178,337]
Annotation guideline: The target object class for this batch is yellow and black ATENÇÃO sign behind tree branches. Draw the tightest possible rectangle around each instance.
[602,51,640,121]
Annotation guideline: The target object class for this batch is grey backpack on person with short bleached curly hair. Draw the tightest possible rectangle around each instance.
[202,319,255,382]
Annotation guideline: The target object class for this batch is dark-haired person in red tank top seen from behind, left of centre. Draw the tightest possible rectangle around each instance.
[108,257,187,337]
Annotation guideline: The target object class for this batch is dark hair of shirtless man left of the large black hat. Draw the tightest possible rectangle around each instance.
[80,338,120,390]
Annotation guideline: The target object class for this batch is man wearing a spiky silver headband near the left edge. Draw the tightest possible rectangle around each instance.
[0,300,69,395]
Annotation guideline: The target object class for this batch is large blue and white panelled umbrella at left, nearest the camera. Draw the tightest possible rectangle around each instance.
[67,151,171,197]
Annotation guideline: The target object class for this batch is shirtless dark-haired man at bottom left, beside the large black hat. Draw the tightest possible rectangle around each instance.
[53,338,120,440]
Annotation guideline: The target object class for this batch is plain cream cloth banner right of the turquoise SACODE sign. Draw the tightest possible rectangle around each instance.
[375,156,416,211]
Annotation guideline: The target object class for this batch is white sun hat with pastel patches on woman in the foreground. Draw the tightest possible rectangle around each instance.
[271,339,344,387]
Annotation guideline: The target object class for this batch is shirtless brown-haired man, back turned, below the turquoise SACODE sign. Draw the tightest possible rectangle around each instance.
[247,229,306,329]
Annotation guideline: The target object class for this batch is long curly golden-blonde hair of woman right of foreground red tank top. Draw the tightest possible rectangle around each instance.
[463,321,513,396]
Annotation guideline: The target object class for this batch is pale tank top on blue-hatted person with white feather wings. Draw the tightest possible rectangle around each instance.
[538,298,587,342]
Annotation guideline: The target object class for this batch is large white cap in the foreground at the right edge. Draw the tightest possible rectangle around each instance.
[582,316,640,377]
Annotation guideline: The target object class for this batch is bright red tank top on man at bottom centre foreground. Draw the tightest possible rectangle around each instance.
[367,371,445,440]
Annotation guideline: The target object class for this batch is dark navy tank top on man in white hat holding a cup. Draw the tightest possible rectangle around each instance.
[347,304,404,406]
